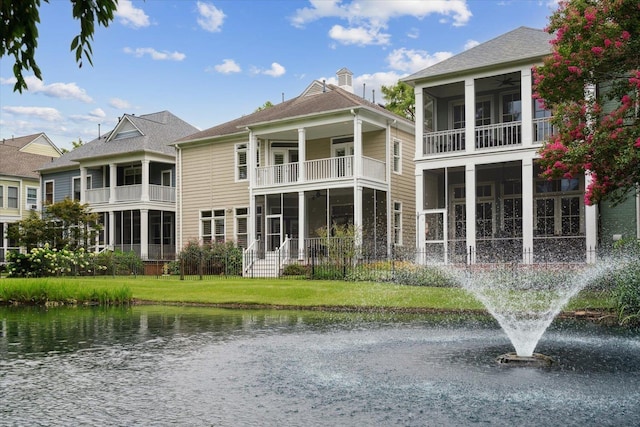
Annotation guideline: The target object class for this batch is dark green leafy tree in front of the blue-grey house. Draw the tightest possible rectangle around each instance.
[7,198,102,250]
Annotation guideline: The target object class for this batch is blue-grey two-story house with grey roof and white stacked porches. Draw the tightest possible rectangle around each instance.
[40,111,198,260]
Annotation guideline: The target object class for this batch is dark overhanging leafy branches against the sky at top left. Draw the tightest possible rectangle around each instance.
[0,0,118,93]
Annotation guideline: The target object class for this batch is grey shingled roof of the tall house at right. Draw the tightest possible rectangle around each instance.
[401,27,554,83]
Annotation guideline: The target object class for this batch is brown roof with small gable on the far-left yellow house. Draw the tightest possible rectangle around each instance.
[0,133,60,179]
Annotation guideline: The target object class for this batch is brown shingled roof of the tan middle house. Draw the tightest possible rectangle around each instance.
[175,81,412,144]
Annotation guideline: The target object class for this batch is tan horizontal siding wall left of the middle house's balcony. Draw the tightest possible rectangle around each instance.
[178,141,249,246]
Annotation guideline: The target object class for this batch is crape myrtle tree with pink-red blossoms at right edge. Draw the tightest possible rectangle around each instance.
[534,0,640,205]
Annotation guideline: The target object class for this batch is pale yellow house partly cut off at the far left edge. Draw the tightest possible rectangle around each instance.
[0,133,62,263]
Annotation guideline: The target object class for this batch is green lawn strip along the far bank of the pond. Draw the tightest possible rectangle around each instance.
[0,276,612,310]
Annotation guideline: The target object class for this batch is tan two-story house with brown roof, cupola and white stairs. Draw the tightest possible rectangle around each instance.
[174,69,415,274]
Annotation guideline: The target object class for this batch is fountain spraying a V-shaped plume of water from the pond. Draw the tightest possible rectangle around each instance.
[461,262,612,366]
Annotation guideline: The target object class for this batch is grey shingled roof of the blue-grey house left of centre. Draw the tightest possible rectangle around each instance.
[41,111,198,171]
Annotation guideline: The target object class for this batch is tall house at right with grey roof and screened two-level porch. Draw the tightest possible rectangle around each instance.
[403,27,640,263]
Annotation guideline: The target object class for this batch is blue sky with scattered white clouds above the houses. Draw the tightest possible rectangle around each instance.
[0,0,556,148]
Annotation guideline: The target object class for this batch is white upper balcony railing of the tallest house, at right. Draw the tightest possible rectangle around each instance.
[422,117,553,155]
